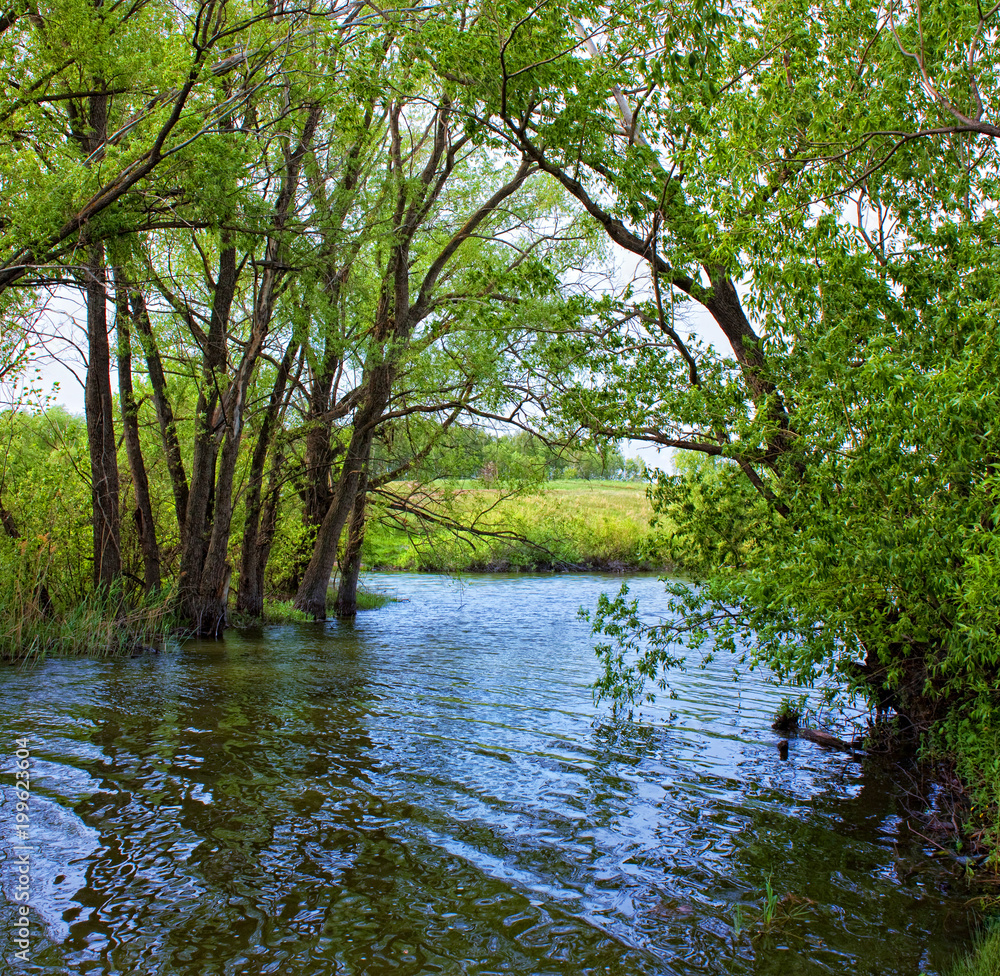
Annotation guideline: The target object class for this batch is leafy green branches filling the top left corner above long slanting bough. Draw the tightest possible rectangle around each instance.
[0,0,324,293]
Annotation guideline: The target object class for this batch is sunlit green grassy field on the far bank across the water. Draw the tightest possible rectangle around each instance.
[363,480,666,572]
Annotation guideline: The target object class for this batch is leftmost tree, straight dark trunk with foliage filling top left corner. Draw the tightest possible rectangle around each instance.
[0,0,358,587]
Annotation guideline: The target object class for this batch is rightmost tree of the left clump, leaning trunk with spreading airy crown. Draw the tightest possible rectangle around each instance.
[286,19,590,616]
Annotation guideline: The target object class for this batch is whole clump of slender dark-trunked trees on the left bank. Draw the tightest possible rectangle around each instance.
[0,0,608,635]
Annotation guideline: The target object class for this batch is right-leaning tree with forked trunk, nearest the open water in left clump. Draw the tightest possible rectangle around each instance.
[296,29,600,617]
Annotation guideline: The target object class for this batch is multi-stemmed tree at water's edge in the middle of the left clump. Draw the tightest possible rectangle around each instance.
[124,13,372,635]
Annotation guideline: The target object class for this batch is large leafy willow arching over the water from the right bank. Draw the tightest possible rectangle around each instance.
[438,0,1000,729]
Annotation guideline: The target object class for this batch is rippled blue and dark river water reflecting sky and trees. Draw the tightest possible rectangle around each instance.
[0,576,984,976]
